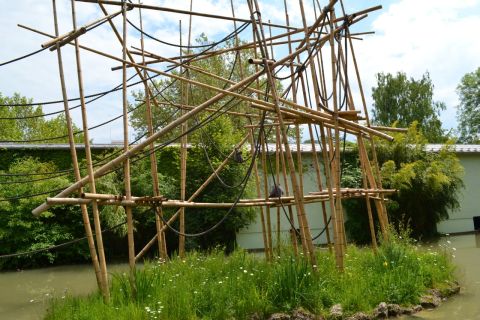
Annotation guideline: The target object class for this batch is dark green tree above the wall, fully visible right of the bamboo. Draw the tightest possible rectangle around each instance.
[372,72,446,143]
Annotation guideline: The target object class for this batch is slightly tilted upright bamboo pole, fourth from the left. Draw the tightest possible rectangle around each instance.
[138,0,167,259]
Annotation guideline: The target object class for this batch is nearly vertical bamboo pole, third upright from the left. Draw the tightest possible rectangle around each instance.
[122,0,137,296]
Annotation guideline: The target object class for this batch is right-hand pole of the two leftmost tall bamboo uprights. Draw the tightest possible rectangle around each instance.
[71,0,110,302]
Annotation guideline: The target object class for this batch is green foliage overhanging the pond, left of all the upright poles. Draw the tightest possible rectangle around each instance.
[0,158,88,269]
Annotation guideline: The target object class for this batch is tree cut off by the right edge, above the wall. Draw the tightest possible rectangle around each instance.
[457,68,480,143]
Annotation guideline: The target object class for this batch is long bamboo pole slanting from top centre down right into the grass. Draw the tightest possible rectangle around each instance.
[248,0,317,269]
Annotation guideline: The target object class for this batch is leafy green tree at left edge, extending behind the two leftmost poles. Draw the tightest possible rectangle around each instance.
[0,157,126,270]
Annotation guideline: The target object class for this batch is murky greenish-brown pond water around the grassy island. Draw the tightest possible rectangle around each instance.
[0,234,480,320]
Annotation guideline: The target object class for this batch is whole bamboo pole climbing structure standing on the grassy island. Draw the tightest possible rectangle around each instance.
[19,0,398,296]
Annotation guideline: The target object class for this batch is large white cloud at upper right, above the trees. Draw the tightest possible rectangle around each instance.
[356,0,480,128]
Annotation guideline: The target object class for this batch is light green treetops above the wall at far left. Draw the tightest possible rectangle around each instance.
[0,93,83,143]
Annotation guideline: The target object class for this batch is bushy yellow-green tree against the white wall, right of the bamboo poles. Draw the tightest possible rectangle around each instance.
[344,122,463,242]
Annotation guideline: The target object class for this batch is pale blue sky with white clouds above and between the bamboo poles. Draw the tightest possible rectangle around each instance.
[0,0,480,143]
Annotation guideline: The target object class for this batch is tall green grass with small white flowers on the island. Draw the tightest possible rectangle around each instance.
[46,235,454,320]
